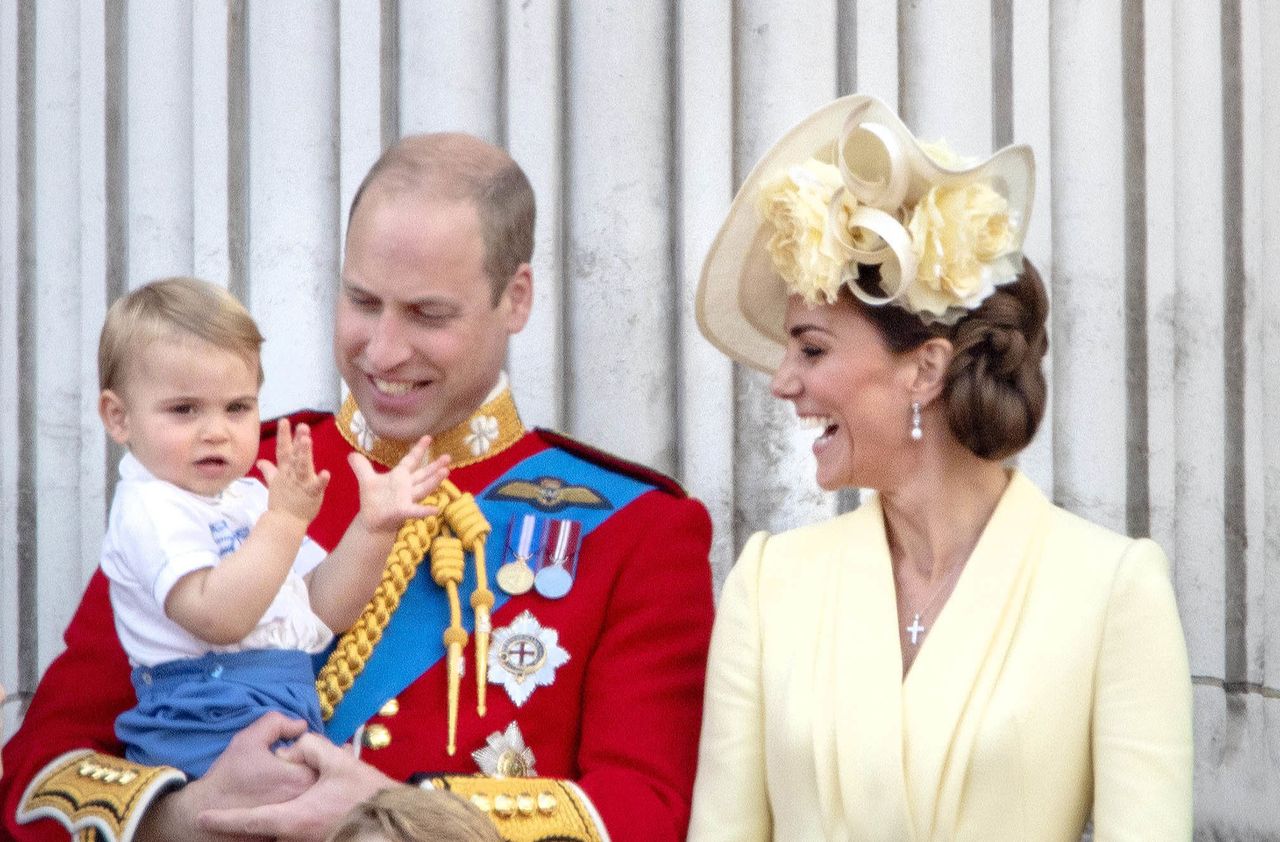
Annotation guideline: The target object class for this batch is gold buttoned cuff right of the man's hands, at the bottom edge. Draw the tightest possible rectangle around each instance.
[430,775,609,842]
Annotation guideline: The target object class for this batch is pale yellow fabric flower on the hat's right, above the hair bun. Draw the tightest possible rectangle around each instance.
[904,176,1018,317]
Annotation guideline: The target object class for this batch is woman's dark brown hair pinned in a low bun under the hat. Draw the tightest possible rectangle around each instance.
[850,260,1048,459]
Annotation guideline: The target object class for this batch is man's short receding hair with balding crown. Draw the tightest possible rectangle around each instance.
[348,133,534,302]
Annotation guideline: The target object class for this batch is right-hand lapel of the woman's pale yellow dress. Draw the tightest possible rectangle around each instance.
[895,472,1051,838]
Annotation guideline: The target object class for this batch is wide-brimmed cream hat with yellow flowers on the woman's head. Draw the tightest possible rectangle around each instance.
[695,95,1036,372]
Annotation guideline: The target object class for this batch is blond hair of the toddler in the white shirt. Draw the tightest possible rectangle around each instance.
[97,278,262,390]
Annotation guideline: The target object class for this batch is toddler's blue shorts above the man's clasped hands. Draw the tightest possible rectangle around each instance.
[115,649,324,778]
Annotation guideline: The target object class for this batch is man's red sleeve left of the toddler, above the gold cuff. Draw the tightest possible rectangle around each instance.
[0,571,136,842]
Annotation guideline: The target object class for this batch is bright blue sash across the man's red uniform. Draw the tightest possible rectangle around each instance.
[325,448,654,745]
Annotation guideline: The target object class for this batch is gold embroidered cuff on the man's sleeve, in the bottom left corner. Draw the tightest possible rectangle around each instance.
[17,749,187,842]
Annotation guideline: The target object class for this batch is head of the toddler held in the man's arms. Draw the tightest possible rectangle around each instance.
[97,278,262,496]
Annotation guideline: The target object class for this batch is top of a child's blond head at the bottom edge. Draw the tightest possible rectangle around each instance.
[328,786,502,842]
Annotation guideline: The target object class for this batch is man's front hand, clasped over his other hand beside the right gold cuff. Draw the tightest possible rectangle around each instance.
[198,733,403,842]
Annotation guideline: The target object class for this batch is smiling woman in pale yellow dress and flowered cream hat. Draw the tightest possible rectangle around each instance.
[689,96,1192,842]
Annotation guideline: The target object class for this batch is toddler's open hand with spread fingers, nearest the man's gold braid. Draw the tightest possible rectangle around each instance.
[347,435,449,532]
